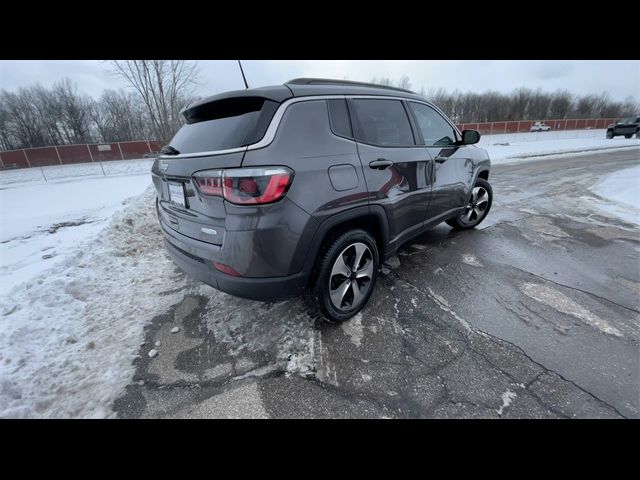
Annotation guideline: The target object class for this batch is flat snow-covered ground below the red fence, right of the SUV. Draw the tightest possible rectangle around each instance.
[478,130,640,165]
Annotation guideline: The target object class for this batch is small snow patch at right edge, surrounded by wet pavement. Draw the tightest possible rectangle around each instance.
[591,165,640,224]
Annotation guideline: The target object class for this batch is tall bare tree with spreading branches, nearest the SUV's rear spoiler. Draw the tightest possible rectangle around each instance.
[111,60,198,143]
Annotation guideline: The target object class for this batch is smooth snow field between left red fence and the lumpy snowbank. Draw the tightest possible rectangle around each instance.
[0,173,151,295]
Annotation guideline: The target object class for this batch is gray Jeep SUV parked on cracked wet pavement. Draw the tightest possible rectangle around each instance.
[152,79,493,321]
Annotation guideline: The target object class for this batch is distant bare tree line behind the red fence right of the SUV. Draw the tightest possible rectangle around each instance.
[372,75,640,123]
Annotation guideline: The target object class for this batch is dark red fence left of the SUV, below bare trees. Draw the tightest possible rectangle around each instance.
[0,140,162,168]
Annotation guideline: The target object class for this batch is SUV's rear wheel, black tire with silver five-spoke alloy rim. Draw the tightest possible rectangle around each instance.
[307,229,379,322]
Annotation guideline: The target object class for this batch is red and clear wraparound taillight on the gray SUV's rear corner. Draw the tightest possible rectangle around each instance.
[193,167,293,205]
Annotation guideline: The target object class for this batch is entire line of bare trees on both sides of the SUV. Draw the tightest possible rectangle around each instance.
[0,60,640,150]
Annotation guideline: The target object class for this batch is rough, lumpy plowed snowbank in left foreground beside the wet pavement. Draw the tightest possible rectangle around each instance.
[0,186,187,418]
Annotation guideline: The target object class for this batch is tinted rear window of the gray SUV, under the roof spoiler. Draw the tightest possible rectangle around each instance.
[170,97,279,153]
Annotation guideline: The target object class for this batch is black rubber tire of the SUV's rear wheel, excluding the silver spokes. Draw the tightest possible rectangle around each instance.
[305,229,380,323]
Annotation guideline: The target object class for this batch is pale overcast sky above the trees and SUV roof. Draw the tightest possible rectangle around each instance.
[0,60,640,100]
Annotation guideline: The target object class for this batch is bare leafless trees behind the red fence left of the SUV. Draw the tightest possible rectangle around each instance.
[0,60,198,150]
